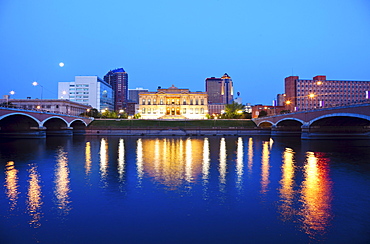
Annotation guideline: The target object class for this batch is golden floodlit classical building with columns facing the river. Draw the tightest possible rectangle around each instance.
[139,85,208,119]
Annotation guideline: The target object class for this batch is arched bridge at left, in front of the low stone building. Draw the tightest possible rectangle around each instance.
[0,108,93,138]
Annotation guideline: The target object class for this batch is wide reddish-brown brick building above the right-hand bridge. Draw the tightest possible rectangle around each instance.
[285,75,370,111]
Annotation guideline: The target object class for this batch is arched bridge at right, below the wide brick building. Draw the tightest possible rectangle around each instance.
[253,103,370,139]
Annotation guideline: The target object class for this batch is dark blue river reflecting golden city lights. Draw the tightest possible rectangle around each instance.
[0,136,370,243]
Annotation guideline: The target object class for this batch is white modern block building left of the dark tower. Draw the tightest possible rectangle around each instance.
[58,76,114,111]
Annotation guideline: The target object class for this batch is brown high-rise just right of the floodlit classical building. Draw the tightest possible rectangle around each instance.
[205,73,234,114]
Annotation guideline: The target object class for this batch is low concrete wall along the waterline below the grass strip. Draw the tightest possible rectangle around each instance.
[84,128,271,136]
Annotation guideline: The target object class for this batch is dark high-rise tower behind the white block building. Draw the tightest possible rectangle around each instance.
[104,68,128,111]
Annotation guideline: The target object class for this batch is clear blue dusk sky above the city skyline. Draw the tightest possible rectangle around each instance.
[0,0,370,104]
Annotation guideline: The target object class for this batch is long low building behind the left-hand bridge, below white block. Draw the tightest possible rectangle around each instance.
[0,99,92,116]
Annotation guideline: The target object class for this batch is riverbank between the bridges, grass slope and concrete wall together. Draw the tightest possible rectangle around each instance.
[81,119,270,136]
